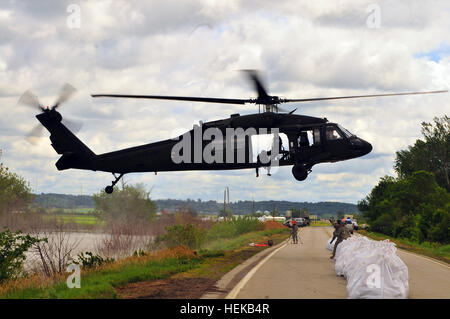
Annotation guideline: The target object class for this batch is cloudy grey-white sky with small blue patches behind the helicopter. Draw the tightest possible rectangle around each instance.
[0,0,450,203]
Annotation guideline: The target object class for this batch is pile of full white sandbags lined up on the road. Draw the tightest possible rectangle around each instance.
[328,236,409,299]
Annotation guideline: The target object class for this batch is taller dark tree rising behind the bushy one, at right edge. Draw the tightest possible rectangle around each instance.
[394,115,450,191]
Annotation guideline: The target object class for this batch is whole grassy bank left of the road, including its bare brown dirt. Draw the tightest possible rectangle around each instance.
[0,228,289,299]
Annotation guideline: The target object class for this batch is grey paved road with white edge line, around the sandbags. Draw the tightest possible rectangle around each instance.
[229,227,450,299]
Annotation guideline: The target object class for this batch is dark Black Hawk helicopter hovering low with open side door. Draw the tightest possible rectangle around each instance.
[19,70,448,194]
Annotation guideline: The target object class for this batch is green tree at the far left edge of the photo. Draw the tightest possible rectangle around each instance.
[0,163,33,216]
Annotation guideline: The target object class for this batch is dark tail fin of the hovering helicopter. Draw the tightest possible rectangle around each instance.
[36,113,97,170]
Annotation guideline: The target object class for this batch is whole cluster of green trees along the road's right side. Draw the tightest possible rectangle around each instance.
[358,115,450,244]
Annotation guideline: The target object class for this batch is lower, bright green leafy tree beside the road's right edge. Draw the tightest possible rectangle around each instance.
[358,171,450,243]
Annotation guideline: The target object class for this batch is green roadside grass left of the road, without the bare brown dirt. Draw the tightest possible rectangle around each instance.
[0,229,289,299]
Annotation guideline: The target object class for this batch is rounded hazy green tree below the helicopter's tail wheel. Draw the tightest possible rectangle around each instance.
[93,184,156,222]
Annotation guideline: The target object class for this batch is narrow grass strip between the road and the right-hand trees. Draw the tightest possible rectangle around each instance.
[358,230,450,263]
